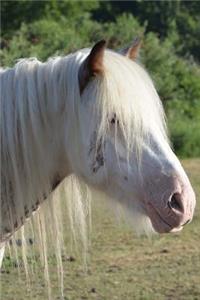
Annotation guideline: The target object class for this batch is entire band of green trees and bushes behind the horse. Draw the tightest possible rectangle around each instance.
[0,0,200,157]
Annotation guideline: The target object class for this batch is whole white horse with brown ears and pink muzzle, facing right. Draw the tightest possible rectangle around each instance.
[0,41,195,270]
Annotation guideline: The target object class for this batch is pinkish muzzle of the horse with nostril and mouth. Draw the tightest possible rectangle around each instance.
[146,178,196,233]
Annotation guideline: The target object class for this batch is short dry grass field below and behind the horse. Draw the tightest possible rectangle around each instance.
[1,159,200,300]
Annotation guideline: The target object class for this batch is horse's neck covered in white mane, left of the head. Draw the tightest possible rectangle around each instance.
[0,58,81,240]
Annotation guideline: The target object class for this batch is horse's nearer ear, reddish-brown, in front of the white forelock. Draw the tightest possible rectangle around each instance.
[78,40,106,93]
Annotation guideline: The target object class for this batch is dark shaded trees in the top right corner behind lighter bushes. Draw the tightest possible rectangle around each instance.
[94,0,200,61]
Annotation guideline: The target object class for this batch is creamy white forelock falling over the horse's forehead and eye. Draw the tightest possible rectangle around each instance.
[80,50,168,161]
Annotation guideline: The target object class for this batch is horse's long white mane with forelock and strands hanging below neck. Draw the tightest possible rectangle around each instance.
[0,49,167,296]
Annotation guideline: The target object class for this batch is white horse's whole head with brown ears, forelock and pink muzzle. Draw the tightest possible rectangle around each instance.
[74,41,195,233]
